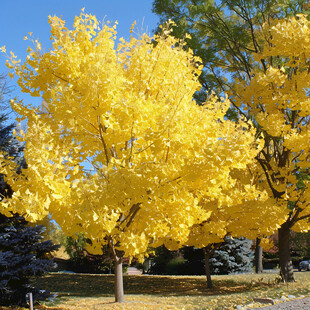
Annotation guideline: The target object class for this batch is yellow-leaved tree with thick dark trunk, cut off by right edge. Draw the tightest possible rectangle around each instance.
[235,14,310,281]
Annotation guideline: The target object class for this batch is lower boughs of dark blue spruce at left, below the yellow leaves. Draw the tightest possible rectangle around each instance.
[0,214,58,306]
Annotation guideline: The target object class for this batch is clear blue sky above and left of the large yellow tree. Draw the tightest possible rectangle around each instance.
[0,0,159,114]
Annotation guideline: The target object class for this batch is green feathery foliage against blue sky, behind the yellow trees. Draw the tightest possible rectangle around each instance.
[153,0,307,93]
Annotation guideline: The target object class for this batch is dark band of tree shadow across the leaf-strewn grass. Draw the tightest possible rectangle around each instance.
[37,273,274,297]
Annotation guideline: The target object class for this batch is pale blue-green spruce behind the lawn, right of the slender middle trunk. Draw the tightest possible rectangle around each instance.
[210,237,254,274]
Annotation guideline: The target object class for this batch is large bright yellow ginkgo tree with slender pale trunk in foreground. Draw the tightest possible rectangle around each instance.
[1,12,262,302]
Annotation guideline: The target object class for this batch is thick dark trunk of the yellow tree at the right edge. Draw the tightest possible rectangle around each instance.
[278,223,295,282]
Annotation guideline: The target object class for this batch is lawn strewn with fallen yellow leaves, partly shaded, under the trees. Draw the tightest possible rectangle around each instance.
[4,272,310,310]
